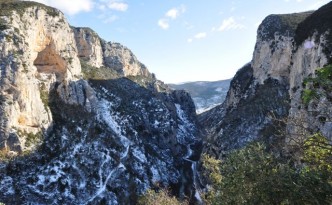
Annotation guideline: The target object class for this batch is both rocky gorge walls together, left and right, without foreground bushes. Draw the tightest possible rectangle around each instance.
[0,0,332,204]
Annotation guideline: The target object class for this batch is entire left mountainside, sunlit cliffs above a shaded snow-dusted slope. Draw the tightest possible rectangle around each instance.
[0,1,202,204]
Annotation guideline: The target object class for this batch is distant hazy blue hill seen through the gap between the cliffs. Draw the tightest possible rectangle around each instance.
[169,79,231,113]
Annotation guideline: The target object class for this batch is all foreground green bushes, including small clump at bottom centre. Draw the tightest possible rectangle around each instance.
[141,133,332,204]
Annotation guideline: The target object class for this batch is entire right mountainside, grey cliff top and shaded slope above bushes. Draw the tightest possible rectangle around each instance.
[200,3,332,157]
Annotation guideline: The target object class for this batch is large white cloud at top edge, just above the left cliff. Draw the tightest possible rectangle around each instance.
[24,0,94,15]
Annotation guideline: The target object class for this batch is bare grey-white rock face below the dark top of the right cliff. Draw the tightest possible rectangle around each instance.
[252,14,331,143]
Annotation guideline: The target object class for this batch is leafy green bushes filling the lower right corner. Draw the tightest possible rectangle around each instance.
[203,140,332,204]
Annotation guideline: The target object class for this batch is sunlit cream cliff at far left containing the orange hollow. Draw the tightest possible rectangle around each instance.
[0,2,81,152]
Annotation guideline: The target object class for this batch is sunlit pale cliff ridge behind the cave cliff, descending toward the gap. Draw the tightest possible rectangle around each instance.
[72,27,170,92]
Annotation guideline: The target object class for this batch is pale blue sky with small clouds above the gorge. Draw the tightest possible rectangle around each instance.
[27,0,329,83]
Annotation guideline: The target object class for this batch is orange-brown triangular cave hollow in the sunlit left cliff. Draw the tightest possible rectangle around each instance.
[33,41,66,80]
